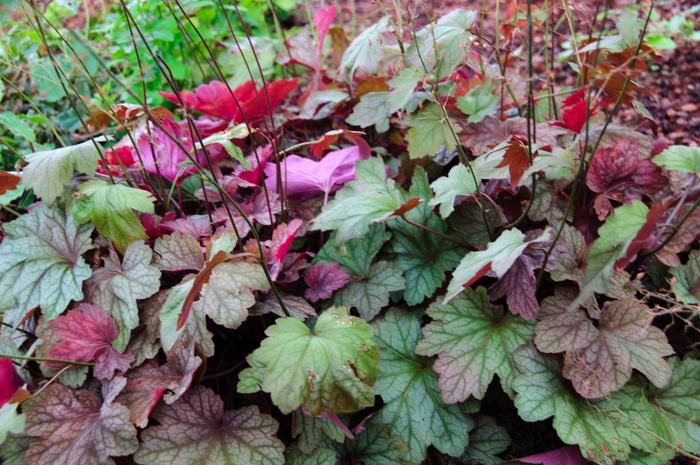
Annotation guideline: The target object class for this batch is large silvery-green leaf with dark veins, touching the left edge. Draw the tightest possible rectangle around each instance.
[0,204,93,325]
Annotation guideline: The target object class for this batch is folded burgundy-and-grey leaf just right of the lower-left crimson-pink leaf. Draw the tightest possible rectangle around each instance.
[116,340,202,428]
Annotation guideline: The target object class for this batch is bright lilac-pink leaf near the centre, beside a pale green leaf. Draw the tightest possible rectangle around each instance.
[265,146,366,199]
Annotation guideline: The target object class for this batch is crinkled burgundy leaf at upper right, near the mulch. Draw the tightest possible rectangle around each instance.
[586,137,668,202]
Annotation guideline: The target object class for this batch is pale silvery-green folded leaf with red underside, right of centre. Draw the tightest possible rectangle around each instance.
[445,228,550,302]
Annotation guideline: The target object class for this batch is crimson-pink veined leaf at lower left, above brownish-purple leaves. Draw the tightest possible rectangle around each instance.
[48,304,134,379]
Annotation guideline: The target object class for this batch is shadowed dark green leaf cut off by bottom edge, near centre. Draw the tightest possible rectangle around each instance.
[324,422,409,465]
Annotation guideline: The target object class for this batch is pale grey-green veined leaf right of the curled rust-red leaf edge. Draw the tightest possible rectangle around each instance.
[193,261,270,329]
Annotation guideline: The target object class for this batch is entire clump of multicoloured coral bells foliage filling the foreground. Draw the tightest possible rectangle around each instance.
[0,6,700,465]
